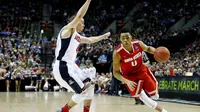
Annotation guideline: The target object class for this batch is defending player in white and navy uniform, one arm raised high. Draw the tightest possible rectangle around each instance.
[53,0,110,112]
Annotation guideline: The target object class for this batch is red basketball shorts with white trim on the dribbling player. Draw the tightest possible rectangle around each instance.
[123,65,158,97]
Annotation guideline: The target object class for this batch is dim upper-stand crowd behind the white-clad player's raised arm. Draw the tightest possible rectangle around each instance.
[52,0,138,36]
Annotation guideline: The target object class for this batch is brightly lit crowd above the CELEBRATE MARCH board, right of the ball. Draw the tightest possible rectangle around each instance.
[151,39,200,76]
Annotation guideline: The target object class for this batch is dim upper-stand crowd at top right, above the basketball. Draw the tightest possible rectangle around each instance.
[132,0,200,46]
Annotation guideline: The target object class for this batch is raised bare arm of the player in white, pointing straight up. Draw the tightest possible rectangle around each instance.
[61,0,91,38]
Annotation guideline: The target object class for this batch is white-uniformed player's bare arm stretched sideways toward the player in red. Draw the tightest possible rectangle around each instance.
[80,32,110,44]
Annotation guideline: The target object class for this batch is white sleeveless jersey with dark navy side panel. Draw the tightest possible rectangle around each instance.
[55,28,81,63]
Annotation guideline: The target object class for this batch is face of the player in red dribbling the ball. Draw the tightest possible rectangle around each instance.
[120,33,132,46]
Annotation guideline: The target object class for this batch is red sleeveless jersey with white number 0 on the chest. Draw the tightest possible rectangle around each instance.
[116,40,143,75]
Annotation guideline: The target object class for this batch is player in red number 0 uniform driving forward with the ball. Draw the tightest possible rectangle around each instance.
[113,30,167,112]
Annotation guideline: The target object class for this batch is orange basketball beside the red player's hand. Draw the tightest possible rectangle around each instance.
[154,47,170,62]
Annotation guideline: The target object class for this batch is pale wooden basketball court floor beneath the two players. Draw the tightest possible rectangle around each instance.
[0,92,200,112]
